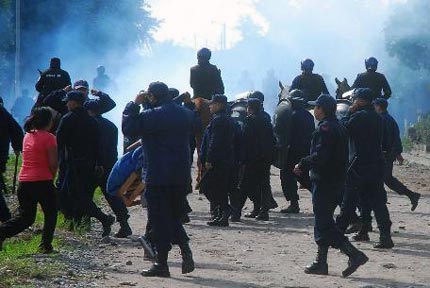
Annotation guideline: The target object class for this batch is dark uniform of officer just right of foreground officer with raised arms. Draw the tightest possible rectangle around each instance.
[200,110,237,215]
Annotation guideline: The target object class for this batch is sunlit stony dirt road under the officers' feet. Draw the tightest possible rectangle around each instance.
[74,155,430,287]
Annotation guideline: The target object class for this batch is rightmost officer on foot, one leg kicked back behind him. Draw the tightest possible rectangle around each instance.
[373,98,421,211]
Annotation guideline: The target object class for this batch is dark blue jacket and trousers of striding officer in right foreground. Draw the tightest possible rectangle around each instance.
[299,118,348,248]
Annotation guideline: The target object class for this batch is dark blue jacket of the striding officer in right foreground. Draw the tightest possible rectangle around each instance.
[299,118,348,184]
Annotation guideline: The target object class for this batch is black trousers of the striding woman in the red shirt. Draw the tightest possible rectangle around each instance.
[0,181,57,245]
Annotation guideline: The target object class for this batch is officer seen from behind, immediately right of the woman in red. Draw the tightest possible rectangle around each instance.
[57,90,115,237]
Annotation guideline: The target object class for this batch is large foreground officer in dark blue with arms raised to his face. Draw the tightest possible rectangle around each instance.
[122,82,194,277]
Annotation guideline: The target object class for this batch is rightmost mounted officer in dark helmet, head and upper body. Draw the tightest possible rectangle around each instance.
[351,57,391,99]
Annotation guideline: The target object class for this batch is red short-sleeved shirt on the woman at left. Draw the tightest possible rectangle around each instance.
[19,130,57,182]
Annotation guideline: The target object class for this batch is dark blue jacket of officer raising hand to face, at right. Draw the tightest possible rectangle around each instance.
[341,105,384,179]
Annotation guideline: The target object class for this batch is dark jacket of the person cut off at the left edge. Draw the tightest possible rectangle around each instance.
[0,107,24,173]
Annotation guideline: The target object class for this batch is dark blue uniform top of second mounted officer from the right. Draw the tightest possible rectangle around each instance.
[290,72,328,101]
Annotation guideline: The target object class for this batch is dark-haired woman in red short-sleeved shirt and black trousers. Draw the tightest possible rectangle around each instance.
[0,107,58,253]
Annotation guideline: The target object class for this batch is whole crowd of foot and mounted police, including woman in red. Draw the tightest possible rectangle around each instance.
[0,48,420,277]
